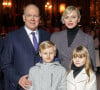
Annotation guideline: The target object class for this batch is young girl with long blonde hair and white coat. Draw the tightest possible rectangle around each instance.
[67,46,97,90]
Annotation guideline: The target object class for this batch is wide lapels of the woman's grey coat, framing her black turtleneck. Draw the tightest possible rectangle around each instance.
[59,30,84,55]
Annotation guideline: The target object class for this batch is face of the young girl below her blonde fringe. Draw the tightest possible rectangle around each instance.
[72,55,86,67]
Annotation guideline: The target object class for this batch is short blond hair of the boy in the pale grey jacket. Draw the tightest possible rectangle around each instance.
[39,41,56,52]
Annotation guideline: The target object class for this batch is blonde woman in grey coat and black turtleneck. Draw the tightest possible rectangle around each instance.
[51,6,96,71]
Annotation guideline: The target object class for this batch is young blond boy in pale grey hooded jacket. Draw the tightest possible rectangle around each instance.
[28,41,67,90]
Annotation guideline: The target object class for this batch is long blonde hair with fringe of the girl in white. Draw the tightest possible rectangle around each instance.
[68,46,93,81]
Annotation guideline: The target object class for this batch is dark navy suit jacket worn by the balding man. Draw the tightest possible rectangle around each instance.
[1,27,50,90]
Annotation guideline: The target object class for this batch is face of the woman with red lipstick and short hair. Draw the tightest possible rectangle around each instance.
[63,11,80,29]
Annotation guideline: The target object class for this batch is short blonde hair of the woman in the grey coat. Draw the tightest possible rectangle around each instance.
[61,6,81,23]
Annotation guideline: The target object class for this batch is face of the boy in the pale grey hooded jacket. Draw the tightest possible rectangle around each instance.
[39,47,56,63]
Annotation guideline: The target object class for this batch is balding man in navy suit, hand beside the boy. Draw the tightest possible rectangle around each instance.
[1,4,50,90]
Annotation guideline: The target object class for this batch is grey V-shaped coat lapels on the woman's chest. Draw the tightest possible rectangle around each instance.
[57,30,83,60]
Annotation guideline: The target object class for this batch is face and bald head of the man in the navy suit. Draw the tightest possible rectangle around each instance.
[23,5,40,31]
